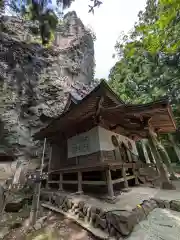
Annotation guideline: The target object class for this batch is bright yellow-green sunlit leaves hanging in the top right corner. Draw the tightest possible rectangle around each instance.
[136,0,180,54]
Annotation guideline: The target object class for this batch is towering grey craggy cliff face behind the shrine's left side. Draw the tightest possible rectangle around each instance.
[0,12,94,180]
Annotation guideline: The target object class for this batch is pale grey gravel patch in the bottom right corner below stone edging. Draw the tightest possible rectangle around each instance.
[127,208,180,240]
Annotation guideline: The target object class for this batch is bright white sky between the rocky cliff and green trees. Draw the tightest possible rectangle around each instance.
[68,0,146,78]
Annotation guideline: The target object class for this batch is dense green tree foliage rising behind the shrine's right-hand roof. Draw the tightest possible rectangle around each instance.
[109,0,180,128]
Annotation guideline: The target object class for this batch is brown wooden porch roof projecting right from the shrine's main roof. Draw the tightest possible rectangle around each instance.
[101,98,176,138]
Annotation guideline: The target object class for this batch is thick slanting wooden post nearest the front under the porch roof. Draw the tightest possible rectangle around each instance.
[149,132,175,189]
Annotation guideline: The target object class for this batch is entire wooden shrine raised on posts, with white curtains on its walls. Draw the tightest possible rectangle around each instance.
[34,81,176,198]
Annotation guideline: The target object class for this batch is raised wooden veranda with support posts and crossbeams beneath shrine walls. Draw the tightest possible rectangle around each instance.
[46,161,156,198]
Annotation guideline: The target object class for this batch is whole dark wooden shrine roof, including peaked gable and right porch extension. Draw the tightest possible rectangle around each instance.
[33,81,176,139]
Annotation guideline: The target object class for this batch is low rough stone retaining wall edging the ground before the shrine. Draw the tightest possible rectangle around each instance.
[40,193,180,239]
